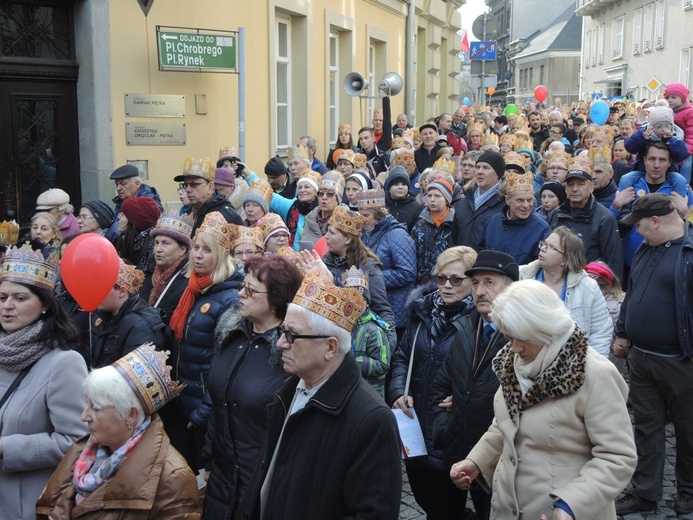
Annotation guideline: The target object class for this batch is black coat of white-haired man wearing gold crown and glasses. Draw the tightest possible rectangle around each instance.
[240,353,402,520]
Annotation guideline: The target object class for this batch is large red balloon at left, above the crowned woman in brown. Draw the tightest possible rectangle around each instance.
[60,233,119,312]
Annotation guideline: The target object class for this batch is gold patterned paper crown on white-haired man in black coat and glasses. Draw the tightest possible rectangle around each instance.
[293,269,366,332]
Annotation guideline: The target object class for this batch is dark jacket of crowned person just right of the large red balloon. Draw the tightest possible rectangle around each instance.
[81,295,164,370]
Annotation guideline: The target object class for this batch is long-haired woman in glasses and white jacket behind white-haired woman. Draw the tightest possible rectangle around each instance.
[520,226,614,357]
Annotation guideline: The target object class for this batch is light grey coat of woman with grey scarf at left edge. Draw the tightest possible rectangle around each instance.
[0,350,87,520]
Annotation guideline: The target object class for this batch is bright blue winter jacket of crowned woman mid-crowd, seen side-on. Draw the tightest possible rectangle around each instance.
[361,215,416,327]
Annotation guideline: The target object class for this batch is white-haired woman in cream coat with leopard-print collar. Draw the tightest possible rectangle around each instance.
[450,280,636,520]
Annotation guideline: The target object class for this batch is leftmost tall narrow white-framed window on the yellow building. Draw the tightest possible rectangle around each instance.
[275,16,291,149]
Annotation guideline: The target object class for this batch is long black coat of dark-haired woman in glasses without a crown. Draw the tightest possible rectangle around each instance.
[202,307,289,520]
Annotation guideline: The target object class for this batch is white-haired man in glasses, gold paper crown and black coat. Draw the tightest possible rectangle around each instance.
[243,270,402,520]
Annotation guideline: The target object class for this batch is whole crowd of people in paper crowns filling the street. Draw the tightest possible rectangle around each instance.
[0,83,693,520]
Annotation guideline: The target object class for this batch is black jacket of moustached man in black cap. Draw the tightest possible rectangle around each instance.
[432,309,507,468]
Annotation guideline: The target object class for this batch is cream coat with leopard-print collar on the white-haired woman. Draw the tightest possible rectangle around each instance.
[469,329,636,520]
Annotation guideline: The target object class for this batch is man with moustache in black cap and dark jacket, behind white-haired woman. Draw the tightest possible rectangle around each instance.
[431,250,519,520]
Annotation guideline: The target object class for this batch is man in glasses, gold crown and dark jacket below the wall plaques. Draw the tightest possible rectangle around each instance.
[173,157,245,236]
